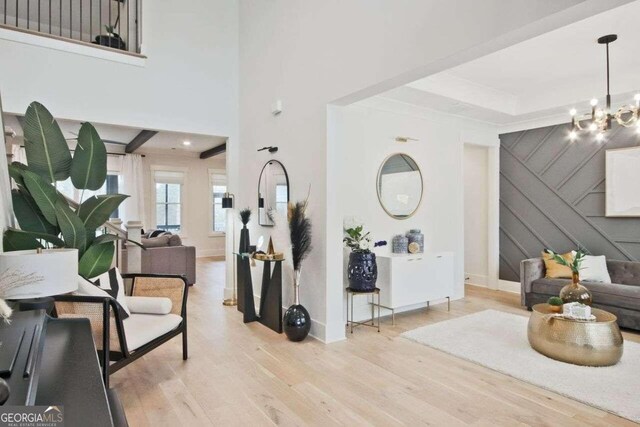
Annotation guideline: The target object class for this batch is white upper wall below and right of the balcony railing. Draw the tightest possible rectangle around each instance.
[0,0,238,137]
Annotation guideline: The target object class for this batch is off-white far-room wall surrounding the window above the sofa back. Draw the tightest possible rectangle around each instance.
[143,151,225,257]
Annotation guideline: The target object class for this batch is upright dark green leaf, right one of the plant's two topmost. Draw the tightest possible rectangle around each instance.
[71,123,107,190]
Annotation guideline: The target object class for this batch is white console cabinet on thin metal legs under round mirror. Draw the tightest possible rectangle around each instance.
[376,252,454,318]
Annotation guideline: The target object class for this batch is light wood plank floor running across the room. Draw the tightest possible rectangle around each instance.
[112,259,640,427]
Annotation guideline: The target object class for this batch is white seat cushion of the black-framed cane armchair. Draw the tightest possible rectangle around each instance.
[122,313,182,351]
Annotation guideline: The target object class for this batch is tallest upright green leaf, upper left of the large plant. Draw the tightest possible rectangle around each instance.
[23,102,71,183]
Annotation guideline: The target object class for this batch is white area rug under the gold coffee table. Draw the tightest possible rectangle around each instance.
[402,310,640,422]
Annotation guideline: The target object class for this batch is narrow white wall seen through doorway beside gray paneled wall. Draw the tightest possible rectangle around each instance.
[464,144,489,286]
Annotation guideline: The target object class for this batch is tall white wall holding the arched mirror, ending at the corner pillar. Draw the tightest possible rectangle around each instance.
[236,0,624,341]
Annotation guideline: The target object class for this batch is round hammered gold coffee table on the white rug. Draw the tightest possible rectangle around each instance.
[527,304,623,366]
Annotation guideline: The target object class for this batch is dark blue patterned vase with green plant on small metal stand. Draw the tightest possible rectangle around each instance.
[343,220,387,292]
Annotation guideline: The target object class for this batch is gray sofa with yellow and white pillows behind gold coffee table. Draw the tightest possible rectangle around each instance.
[520,258,640,330]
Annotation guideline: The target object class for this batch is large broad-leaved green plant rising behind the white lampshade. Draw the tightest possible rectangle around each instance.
[3,102,134,278]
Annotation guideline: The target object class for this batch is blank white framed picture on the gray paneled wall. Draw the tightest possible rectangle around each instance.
[605,147,640,217]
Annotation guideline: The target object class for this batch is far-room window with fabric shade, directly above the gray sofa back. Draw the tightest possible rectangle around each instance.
[154,170,184,233]
